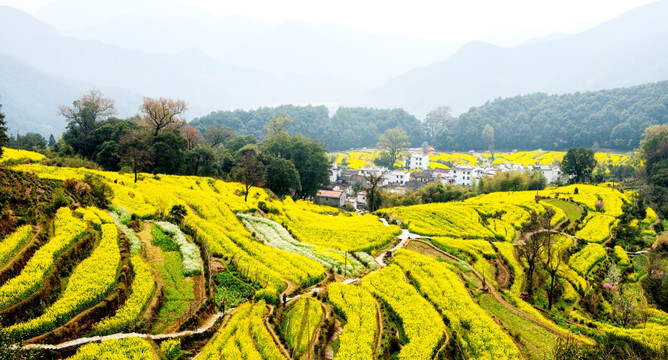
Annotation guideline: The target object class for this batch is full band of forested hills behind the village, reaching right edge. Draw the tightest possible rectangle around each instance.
[191,81,668,151]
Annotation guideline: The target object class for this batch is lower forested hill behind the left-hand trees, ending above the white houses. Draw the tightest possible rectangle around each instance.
[190,105,423,151]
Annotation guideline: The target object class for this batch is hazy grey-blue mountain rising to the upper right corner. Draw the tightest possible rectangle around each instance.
[357,0,668,117]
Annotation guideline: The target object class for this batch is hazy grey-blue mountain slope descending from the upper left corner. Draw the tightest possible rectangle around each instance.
[0,7,357,131]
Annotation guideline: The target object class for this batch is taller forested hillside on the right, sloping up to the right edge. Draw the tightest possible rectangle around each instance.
[434,81,668,150]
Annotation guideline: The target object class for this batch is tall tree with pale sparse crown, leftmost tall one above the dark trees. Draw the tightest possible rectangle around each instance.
[59,90,117,158]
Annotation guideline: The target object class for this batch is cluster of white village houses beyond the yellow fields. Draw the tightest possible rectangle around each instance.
[314,152,564,209]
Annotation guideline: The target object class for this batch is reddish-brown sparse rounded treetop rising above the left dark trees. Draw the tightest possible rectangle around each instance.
[139,96,188,136]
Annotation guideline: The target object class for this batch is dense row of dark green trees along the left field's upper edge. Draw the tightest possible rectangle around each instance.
[0,90,329,197]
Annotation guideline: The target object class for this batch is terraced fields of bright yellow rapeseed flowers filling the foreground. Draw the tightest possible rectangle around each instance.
[0,156,668,359]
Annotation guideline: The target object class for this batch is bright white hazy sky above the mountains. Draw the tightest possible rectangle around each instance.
[0,0,655,43]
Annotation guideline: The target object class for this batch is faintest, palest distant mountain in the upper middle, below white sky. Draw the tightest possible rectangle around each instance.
[35,0,459,88]
